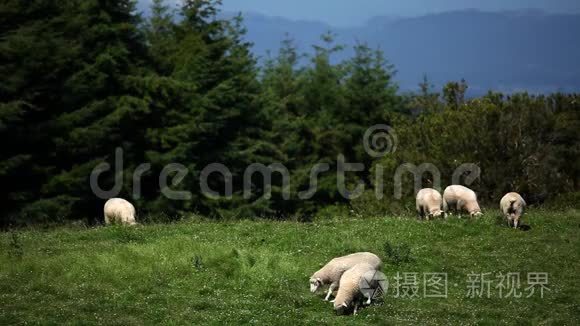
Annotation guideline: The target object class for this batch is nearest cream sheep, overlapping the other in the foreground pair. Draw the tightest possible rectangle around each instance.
[334,263,380,315]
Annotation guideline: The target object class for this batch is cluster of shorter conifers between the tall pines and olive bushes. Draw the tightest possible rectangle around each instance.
[262,35,401,214]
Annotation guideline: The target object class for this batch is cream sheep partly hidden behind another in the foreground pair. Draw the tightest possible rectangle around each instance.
[310,252,382,301]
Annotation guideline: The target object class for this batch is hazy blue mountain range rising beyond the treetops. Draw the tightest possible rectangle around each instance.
[237,10,580,94]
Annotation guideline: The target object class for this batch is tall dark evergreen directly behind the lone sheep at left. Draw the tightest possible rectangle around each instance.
[33,0,150,224]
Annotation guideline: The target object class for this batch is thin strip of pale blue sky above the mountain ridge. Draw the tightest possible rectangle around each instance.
[223,0,580,26]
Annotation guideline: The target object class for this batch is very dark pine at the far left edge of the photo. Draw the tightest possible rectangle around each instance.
[0,0,82,225]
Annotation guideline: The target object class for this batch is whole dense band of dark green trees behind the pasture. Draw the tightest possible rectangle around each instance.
[0,0,580,228]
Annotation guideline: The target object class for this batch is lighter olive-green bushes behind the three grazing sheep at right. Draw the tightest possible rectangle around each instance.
[375,88,580,208]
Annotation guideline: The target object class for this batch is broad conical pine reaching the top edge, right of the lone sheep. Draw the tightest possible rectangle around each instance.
[140,1,275,219]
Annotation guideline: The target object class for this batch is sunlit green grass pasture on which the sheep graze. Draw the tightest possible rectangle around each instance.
[0,210,580,325]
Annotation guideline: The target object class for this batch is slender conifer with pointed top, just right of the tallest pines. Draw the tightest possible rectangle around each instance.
[261,35,320,214]
